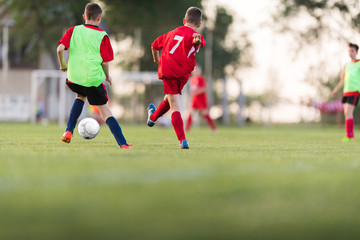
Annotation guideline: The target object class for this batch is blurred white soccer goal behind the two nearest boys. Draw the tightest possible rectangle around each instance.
[30,69,188,126]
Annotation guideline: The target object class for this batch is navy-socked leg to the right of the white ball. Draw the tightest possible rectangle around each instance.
[97,104,130,148]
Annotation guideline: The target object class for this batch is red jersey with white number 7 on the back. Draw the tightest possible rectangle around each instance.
[151,26,206,80]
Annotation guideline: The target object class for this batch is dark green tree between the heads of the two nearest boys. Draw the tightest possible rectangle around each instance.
[102,0,202,70]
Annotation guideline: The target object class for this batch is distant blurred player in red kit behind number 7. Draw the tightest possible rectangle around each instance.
[185,66,216,132]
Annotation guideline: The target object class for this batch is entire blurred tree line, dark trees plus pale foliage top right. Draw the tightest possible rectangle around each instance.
[7,0,360,124]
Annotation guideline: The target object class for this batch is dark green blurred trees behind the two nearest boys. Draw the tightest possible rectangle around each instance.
[0,0,250,78]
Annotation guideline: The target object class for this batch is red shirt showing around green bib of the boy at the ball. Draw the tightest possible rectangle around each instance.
[58,24,114,62]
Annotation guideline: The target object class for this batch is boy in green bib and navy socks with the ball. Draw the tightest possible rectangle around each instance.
[57,3,130,149]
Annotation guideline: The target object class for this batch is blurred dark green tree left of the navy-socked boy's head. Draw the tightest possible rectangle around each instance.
[0,0,88,66]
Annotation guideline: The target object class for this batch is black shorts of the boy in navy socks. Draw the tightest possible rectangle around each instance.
[66,79,109,105]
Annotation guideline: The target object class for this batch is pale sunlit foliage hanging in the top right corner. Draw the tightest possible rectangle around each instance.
[274,0,360,43]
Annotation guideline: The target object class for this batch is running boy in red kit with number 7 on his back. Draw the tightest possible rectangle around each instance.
[147,7,206,149]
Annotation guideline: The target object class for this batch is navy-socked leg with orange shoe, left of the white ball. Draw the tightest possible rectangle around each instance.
[61,94,86,143]
